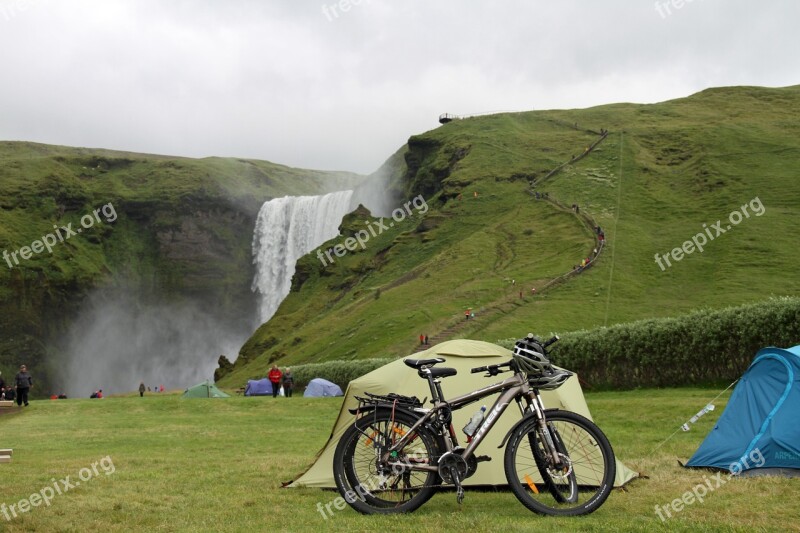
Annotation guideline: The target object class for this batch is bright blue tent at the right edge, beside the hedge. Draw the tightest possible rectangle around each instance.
[686,346,800,475]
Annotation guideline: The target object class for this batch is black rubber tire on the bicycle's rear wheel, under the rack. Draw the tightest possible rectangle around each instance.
[333,410,441,514]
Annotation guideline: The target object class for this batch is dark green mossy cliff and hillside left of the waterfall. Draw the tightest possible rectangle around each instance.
[0,142,362,388]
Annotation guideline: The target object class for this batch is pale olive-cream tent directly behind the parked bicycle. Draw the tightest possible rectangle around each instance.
[290,340,638,488]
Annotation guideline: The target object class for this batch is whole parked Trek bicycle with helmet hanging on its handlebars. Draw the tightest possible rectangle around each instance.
[333,334,616,516]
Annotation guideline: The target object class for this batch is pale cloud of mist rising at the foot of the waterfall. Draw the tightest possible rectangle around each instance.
[54,289,253,398]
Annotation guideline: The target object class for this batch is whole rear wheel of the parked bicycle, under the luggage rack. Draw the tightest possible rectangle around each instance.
[333,410,441,514]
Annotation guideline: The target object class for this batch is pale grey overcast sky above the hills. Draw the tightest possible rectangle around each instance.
[0,0,800,173]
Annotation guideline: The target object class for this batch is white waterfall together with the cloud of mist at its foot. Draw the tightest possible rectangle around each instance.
[52,170,399,398]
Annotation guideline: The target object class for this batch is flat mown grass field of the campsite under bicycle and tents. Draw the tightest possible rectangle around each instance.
[0,389,800,532]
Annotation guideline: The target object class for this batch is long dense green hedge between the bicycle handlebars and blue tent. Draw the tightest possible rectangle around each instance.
[501,298,800,389]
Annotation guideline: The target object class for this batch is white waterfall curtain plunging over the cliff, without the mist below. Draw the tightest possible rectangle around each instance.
[253,191,353,323]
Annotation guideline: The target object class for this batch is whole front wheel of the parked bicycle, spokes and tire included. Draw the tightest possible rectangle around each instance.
[505,410,616,516]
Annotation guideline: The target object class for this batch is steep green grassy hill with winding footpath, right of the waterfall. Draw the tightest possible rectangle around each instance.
[222,86,800,386]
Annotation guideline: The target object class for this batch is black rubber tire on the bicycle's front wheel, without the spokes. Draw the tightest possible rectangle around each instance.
[504,409,616,516]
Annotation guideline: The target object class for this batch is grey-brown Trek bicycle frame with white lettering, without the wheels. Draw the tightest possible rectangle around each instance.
[386,373,544,471]
